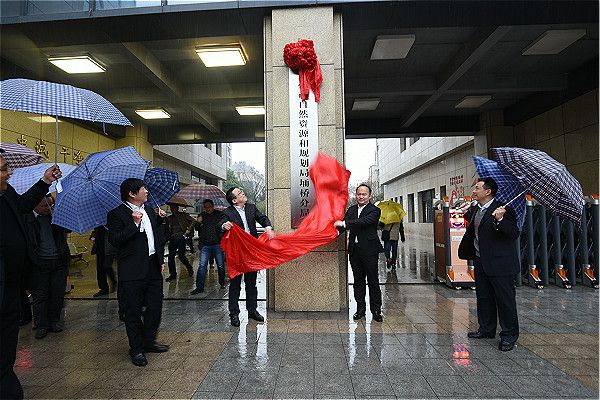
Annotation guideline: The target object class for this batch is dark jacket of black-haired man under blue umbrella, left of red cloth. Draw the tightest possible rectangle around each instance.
[107,204,162,281]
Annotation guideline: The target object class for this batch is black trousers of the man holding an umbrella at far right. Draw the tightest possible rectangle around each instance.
[473,258,519,343]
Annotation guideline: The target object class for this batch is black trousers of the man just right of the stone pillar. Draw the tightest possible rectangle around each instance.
[350,243,381,312]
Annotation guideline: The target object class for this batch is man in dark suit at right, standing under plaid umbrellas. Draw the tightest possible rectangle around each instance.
[458,178,520,351]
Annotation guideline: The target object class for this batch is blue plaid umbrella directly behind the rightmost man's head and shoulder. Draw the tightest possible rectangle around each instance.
[473,156,525,229]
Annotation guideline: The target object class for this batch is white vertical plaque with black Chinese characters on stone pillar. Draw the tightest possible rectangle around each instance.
[289,70,319,228]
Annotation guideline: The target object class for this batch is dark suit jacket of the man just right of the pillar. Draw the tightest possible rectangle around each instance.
[340,203,383,255]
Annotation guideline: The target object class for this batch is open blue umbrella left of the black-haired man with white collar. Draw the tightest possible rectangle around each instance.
[52,146,148,234]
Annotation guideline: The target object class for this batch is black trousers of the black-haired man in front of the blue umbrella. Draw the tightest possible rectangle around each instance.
[119,256,163,355]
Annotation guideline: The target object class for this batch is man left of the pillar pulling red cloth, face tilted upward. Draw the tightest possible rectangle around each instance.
[217,188,275,327]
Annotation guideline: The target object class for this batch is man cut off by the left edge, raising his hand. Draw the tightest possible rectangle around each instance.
[0,151,61,399]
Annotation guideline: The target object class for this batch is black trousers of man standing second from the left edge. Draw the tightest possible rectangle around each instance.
[30,260,67,328]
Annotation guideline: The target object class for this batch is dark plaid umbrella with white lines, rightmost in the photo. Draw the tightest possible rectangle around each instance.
[492,147,584,224]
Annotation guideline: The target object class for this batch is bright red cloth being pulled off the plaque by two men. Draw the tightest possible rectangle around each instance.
[221,153,350,278]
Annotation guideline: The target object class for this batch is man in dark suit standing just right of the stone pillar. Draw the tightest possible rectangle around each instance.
[334,184,383,322]
